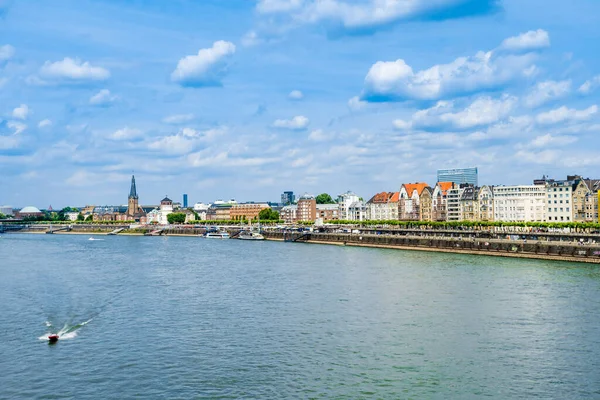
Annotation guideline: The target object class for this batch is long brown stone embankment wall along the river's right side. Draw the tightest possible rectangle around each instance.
[265,232,600,264]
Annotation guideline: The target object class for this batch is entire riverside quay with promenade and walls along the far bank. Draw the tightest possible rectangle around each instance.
[0,224,600,264]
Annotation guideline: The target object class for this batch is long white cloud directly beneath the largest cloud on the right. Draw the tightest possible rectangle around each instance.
[394,95,517,130]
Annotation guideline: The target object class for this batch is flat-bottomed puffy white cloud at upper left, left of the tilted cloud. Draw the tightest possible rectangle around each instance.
[40,57,110,82]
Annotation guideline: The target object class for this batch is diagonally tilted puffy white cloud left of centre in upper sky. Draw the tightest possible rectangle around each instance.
[171,40,235,87]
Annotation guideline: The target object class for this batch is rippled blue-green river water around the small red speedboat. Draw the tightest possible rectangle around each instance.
[0,234,600,399]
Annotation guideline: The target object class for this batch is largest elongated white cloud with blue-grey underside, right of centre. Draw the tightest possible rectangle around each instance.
[363,51,536,101]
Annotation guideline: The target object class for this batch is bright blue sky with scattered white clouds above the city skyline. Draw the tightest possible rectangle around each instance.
[0,0,600,208]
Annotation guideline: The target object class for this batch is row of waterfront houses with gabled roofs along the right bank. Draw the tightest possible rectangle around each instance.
[281,175,600,222]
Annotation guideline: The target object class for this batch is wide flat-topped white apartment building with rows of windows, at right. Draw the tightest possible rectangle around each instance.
[493,185,546,222]
